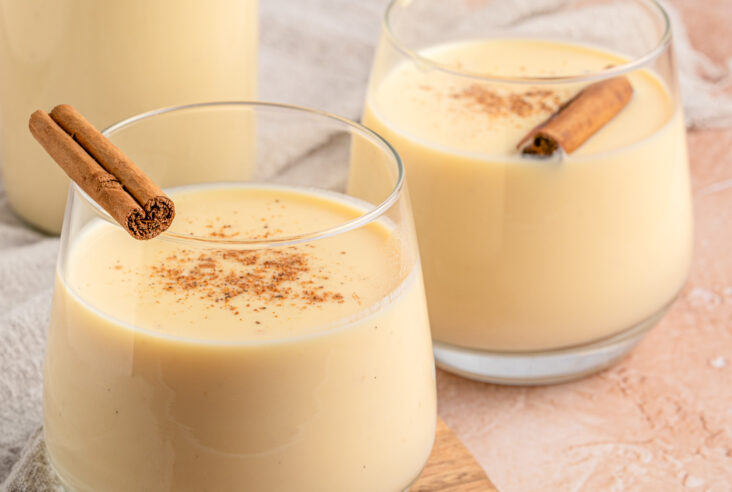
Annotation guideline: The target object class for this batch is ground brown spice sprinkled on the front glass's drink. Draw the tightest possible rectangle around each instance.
[149,244,345,315]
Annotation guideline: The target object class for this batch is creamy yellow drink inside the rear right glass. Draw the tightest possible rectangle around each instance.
[360,39,691,351]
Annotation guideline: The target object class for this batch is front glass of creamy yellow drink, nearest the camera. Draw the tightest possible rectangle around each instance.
[44,103,436,492]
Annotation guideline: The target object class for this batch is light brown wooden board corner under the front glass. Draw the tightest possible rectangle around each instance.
[410,418,498,492]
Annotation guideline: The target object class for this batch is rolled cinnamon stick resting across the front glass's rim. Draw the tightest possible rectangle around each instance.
[28,104,175,239]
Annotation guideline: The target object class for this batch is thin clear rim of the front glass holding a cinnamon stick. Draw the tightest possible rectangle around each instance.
[71,101,404,249]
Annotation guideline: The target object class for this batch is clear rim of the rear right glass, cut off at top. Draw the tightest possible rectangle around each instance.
[382,0,671,84]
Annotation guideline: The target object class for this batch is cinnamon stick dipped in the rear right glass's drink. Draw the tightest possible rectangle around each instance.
[517,76,633,157]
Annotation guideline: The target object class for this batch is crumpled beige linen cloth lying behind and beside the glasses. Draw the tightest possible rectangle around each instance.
[0,0,732,492]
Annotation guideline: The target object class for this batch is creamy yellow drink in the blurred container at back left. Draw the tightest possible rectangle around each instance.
[0,0,258,233]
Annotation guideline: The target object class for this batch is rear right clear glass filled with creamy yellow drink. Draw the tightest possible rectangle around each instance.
[359,0,692,384]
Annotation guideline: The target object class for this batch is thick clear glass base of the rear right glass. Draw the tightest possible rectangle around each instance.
[433,298,675,386]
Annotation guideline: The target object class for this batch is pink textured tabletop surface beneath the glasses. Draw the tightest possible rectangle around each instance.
[438,0,732,492]
